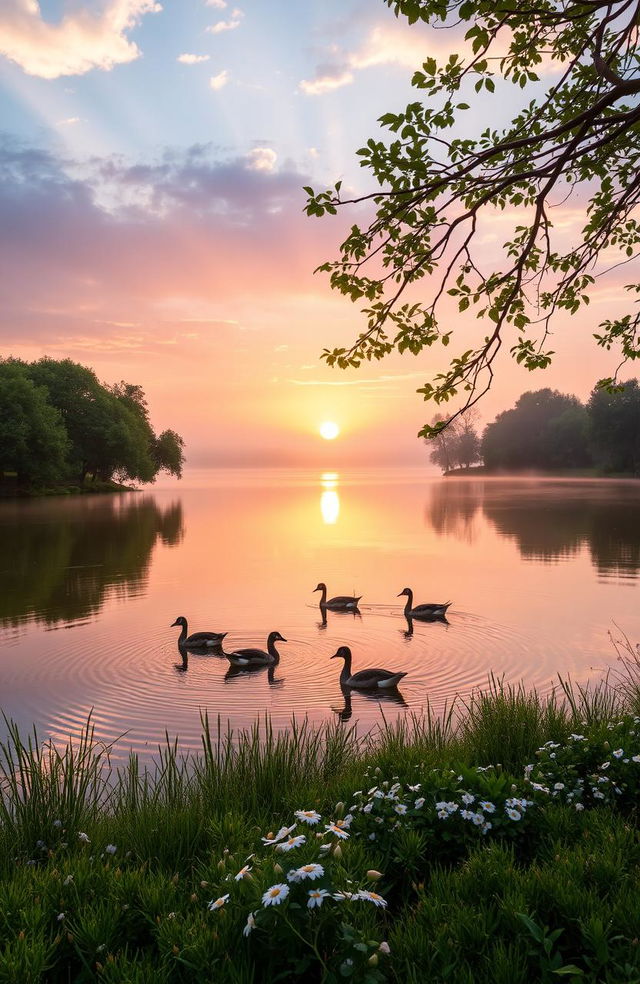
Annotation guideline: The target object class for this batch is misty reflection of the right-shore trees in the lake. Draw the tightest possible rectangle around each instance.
[427,479,640,577]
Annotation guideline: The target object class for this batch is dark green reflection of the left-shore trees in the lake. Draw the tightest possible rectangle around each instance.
[0,496,184,625]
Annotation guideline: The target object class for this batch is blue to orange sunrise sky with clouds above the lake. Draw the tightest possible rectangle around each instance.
[0,0,632,467]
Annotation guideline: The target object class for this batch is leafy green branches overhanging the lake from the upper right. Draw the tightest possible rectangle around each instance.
[305,0,640,436]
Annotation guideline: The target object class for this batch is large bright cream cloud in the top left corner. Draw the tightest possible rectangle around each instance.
[0,0,162,79]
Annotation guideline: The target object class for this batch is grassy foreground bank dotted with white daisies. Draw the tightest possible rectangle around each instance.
[0,644,640,984]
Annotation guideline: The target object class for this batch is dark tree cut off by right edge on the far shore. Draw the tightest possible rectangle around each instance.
[587,379,640,475]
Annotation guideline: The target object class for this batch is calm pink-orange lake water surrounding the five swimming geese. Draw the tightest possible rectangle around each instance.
[0,470,640,756]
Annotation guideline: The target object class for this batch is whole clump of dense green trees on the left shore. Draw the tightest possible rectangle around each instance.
[0,358,184,490]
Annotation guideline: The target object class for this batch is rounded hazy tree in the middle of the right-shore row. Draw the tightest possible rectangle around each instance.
[482,389,591,471]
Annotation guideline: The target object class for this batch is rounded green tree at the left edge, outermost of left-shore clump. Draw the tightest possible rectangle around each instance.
[0,359,69,487]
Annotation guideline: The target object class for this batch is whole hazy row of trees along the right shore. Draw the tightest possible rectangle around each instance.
[427,379,640,475]
